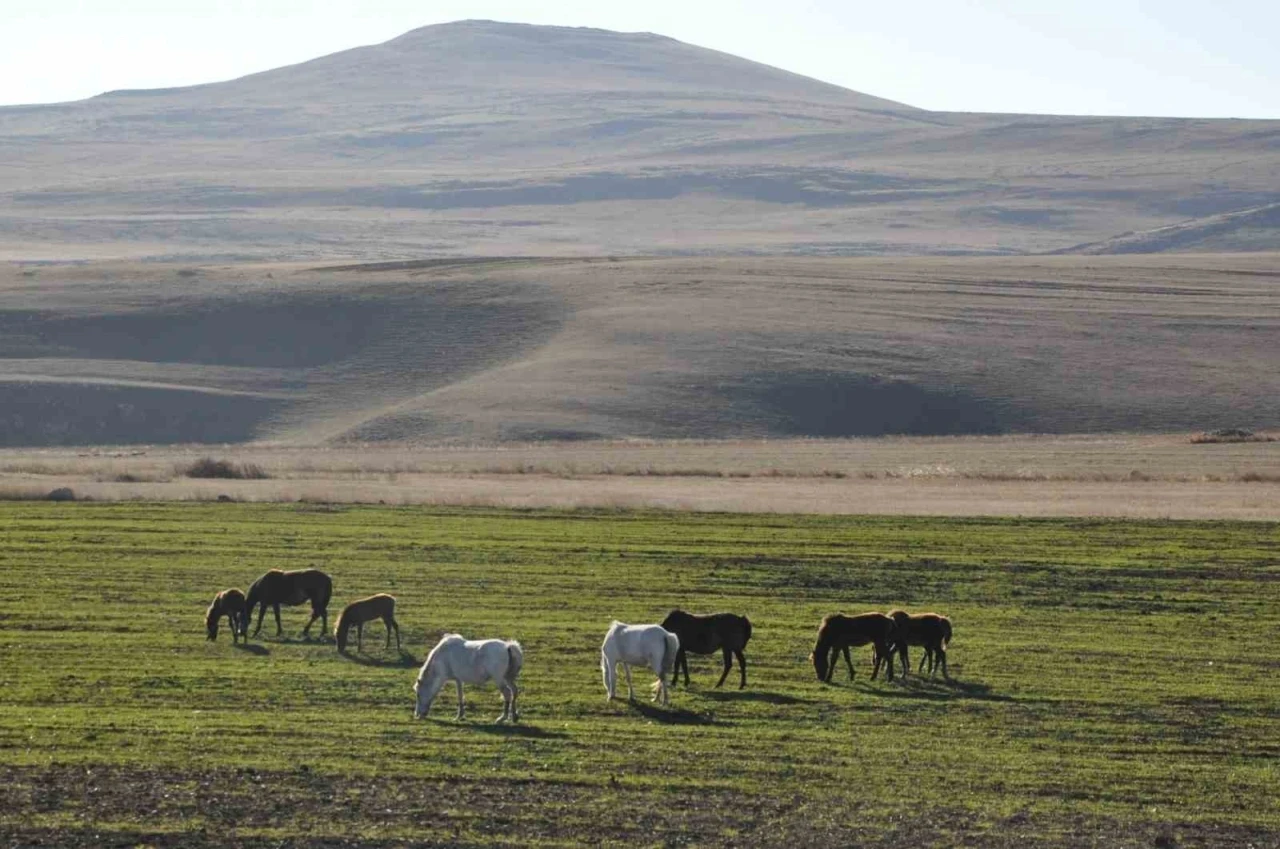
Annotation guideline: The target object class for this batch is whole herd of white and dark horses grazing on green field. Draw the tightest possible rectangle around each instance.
[205,569,951,722]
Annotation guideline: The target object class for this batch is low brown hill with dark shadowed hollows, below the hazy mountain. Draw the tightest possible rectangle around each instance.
[0,254,1280,446]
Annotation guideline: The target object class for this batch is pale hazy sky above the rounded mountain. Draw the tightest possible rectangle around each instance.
[0,0,1280,118]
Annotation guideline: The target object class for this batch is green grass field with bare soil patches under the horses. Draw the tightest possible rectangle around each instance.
[0,503,1280,846]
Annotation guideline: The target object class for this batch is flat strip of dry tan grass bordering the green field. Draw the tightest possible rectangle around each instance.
[0,434,1280,520]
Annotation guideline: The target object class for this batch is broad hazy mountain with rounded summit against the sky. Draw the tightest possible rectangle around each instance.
[0,20,1280,260]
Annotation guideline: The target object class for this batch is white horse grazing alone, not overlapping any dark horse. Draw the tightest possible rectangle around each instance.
[413,634,525,722]
